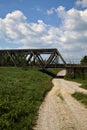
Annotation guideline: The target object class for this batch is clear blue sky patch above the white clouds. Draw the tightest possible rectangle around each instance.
[0,0,75,26]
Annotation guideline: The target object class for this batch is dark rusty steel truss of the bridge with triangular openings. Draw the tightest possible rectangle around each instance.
[0,48,66,68]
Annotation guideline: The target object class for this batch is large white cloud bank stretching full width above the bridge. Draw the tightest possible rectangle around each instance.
[0,9,87,61]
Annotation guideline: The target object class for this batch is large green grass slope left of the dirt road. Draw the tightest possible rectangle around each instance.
[0,67,52,130]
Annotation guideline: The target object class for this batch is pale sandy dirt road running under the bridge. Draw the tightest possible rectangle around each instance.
[34,70,87,130]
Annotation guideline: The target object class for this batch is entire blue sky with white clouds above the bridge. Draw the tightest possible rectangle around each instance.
[0,0,87,62]
